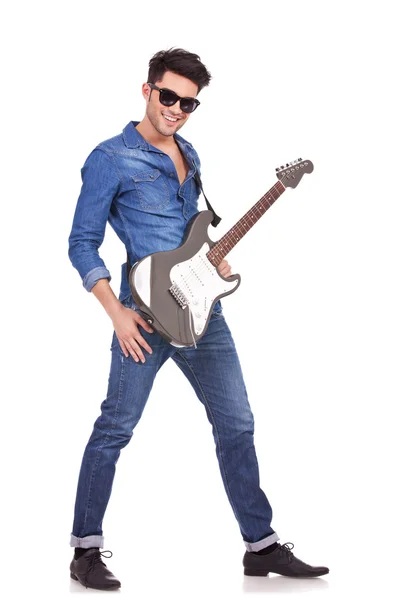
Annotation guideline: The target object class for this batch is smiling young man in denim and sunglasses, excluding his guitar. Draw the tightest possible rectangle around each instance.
[69,49,329,590]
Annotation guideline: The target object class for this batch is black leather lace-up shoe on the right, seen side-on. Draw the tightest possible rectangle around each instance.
[243,542,329,577]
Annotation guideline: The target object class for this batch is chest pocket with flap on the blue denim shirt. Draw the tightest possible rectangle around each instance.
[131,169,170,211]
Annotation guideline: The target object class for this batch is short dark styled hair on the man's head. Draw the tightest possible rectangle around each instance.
[147,48,211,93]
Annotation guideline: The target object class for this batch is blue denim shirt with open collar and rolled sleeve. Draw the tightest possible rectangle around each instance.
[68,121,205,300]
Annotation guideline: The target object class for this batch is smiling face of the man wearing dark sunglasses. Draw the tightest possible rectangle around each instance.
[143,71,198,136]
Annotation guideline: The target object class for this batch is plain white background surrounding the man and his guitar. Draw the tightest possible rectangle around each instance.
[1,0,400,598]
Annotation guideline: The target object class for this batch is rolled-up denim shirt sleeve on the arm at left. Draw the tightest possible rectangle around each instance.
[68,148,120,292]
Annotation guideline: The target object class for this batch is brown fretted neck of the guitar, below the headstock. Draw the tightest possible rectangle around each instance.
[207,181,286,267]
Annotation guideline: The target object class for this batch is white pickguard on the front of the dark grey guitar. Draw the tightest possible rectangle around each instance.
[170,242,239,335]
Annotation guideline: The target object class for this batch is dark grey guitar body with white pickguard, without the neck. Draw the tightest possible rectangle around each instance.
[129,210,240,347]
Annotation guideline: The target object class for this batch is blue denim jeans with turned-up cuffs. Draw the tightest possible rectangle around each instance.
[70,296,279,552]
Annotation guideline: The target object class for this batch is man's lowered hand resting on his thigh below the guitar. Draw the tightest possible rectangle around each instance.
[112,304,153,363]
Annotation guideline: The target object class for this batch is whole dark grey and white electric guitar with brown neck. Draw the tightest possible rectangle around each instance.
[128,158,314,348]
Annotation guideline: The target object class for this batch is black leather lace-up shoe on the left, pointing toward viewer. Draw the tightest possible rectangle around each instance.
[70,548,121,590]
